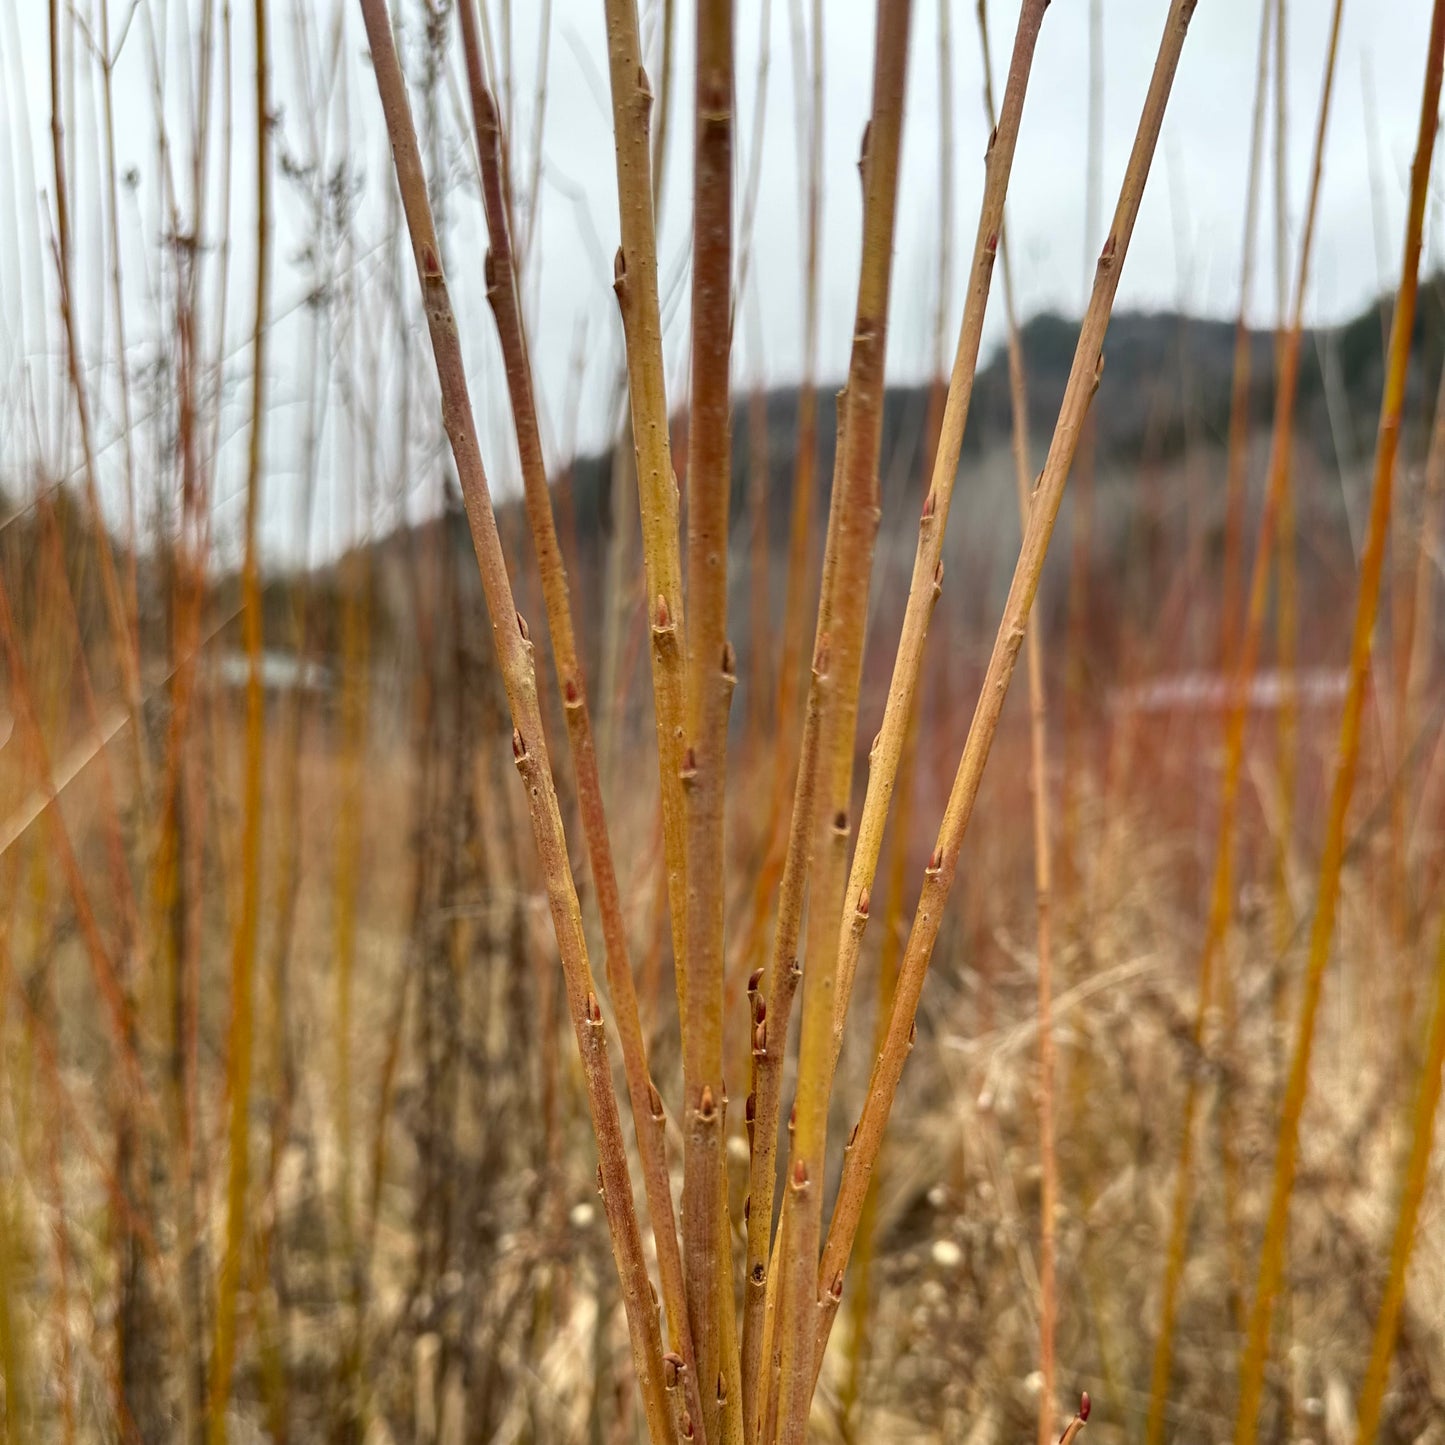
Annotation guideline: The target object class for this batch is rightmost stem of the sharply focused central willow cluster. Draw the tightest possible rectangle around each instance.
[815,0,1195,1366]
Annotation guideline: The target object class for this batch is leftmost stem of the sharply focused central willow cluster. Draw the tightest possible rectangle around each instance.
[360,0,673,1445]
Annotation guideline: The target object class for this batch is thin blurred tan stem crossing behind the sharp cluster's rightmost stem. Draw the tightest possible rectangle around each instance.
[978,8,1059,1445]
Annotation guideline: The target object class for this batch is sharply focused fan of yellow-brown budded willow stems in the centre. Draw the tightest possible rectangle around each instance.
[361,0,1194,1442]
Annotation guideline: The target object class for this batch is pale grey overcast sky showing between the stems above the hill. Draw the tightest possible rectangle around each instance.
[0,0,1438,560]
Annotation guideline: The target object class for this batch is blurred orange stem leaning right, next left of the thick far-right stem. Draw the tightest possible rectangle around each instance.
[1146,0,1344,1445]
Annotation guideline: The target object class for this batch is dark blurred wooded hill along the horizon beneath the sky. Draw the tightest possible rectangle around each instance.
[0,276,1445,693]
